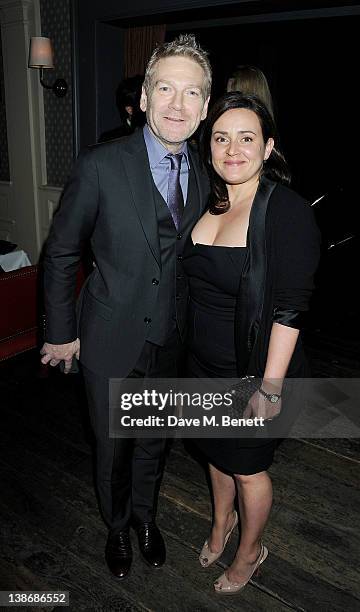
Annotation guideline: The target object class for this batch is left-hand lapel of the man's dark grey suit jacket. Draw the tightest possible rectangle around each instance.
[122,130,161,266]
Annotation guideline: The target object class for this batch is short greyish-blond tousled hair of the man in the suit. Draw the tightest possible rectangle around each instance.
[144,34,212,100]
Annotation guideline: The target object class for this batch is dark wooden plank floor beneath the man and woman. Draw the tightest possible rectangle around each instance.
[0,334,360,612]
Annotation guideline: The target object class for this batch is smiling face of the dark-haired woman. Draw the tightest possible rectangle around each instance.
[211,108,274,185]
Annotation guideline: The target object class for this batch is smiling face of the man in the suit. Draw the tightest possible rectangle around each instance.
[140,56,209,153]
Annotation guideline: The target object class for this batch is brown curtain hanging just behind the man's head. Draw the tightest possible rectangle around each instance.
[125,25,166,78]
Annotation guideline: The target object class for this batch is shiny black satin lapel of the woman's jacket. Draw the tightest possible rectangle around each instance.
[235,177,276,376]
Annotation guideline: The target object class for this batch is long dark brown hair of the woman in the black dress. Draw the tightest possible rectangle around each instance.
[200,91,291,215]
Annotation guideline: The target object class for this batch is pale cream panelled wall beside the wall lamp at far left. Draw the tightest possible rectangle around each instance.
[0,0,61,263]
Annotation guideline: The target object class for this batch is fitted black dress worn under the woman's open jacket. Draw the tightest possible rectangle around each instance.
[183,237,277,474]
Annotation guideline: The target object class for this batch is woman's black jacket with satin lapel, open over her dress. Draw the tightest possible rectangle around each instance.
[235,177,320,377]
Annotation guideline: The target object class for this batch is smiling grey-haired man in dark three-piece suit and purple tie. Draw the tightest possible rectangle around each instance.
[41,35,211,578]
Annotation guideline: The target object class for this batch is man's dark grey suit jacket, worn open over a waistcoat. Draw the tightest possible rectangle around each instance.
[44,130,208,377]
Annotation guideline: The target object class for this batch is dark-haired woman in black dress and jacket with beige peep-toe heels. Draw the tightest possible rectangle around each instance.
[184,92,320,595]
